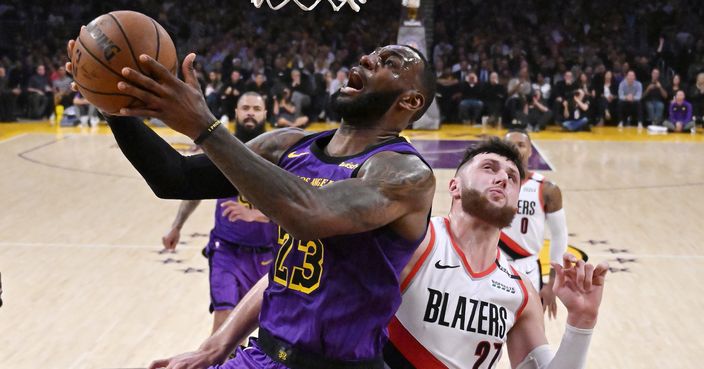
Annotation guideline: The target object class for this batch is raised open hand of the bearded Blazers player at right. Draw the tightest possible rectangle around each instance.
[552,253,609,328]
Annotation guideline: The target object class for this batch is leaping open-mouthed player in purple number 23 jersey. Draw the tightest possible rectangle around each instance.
[68,42,435,369]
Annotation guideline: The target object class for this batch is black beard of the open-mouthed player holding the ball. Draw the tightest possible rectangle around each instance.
[330,90,403,127]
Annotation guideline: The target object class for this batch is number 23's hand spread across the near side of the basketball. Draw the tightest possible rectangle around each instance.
[117,53,215,139]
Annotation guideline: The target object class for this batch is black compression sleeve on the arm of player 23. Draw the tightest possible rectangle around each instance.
[107,117,237,200]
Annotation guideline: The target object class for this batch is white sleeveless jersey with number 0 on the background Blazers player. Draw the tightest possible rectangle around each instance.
[500,173,546,259]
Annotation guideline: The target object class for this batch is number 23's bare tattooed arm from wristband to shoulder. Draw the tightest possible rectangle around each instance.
[203,130,435,239]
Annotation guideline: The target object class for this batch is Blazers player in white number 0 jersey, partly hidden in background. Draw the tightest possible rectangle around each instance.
[499,130,567,317]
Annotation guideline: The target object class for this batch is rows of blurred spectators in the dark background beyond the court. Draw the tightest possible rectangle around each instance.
[0,0,704,130]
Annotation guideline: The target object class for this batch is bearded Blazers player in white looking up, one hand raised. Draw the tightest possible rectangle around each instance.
[384,139,608,369]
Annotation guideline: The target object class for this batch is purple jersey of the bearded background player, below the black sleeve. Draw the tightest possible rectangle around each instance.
[211,196,277,247]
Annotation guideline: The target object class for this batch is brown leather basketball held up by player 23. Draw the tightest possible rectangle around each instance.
[71,10,178,113]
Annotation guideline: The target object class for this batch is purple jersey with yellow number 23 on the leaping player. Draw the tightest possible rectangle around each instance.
[260,131,422,360]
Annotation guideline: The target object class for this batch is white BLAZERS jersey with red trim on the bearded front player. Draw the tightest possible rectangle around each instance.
[384,217,528,369]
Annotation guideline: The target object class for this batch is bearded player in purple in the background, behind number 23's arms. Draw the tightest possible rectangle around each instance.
[162,92,276,333]
